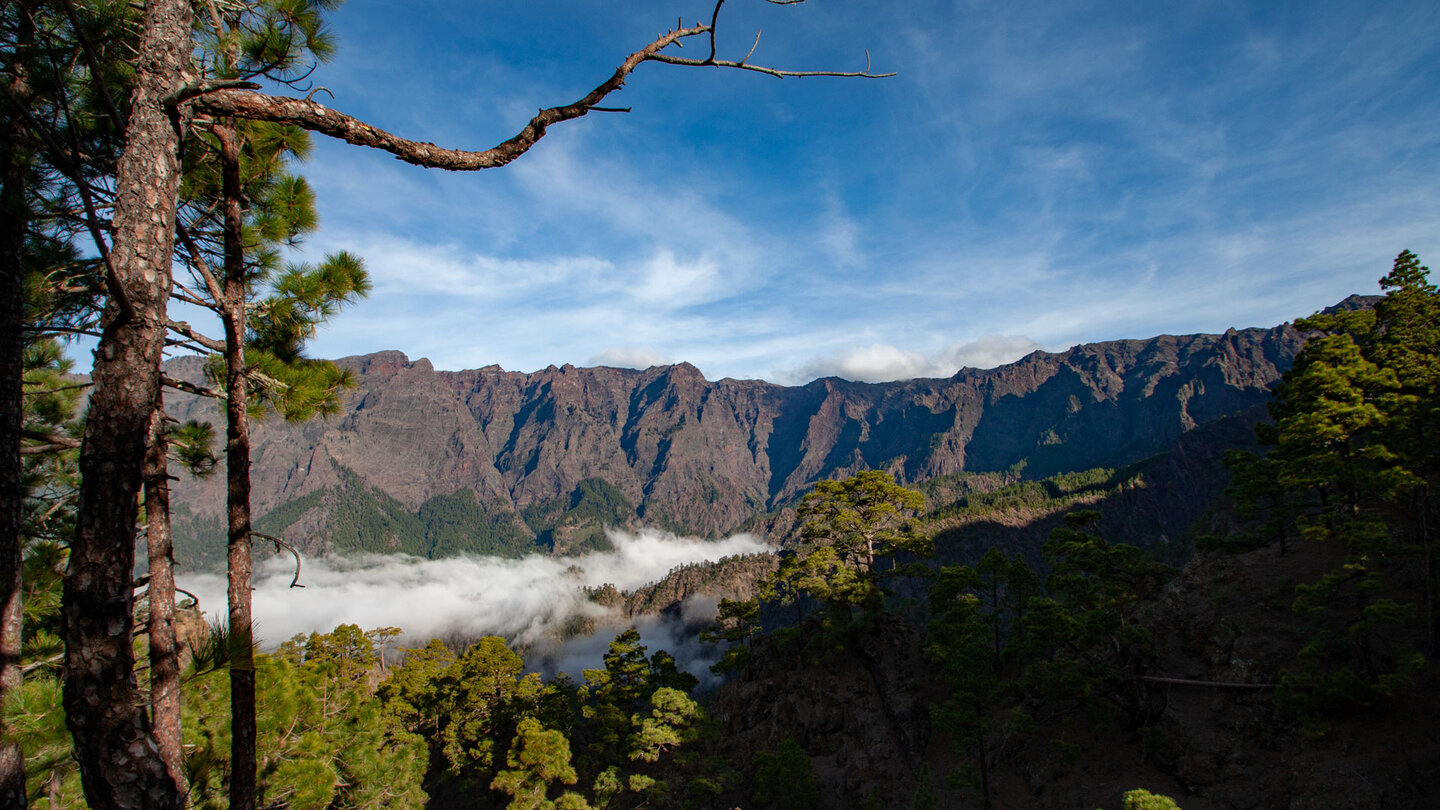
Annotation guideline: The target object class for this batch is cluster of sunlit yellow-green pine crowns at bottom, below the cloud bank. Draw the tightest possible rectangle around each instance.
[377,628,719,809]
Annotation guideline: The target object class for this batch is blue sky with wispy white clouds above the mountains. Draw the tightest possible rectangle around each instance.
[253,0,1440,383]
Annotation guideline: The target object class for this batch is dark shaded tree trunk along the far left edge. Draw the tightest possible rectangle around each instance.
[0,69,29,807]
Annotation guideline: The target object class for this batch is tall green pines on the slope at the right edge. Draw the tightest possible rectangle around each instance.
[1230,251,1440,734]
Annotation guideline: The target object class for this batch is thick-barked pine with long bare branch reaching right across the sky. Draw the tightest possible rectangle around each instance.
[25,0,873,810]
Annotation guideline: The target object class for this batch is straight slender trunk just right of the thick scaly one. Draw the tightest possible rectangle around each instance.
[216,124,256,810]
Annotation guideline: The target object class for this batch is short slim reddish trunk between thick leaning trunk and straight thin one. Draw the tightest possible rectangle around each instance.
[145,399,187,794]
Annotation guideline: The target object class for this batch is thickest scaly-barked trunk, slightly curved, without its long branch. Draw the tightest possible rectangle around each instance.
[62,0,192,810]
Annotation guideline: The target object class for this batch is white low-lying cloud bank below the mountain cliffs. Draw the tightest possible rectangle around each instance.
[179,530,769,651]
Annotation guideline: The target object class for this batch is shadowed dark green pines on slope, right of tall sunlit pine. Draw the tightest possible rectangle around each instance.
[927,510,1171,807]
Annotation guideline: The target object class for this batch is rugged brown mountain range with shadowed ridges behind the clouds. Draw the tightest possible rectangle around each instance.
[168,315,1313,565]
